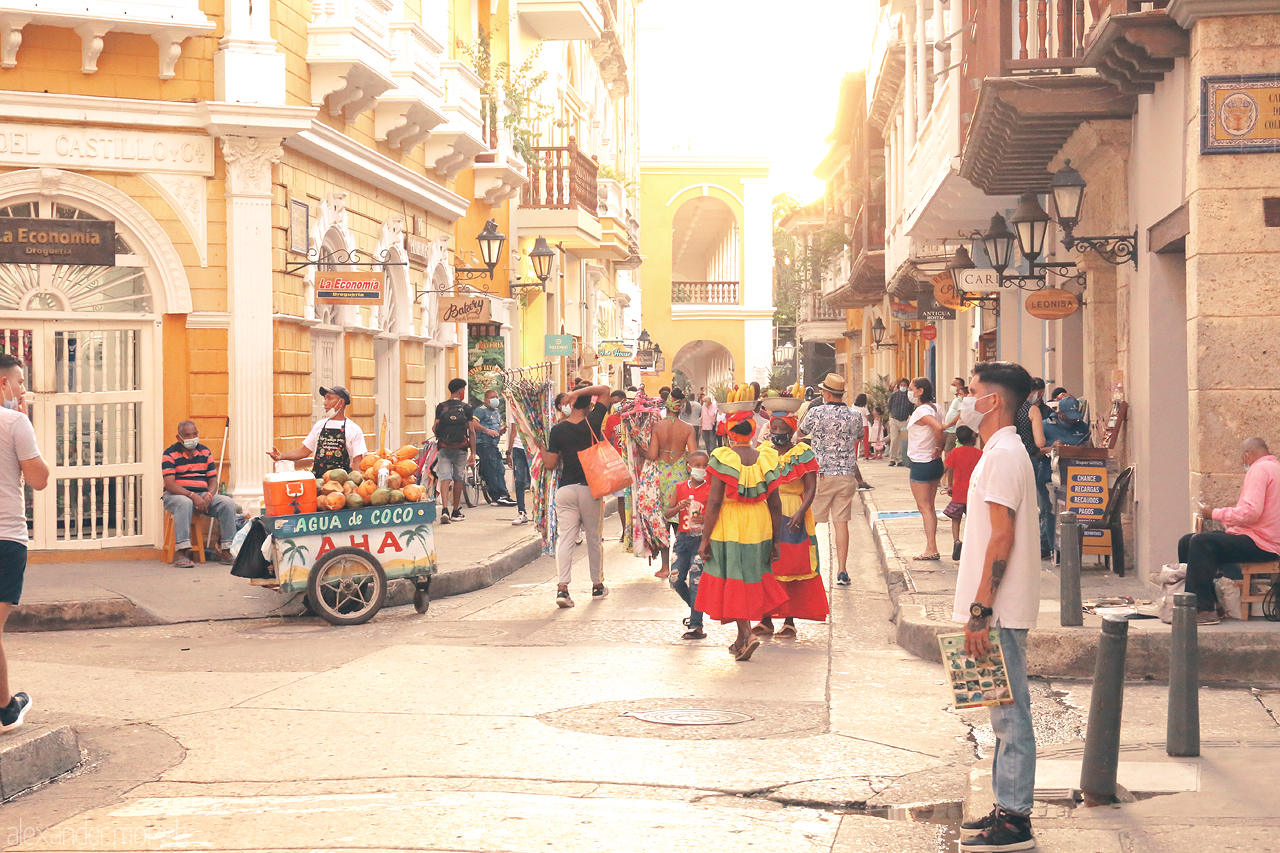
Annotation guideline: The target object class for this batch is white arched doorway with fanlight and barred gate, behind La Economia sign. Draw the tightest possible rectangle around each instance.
[0,189,167,551]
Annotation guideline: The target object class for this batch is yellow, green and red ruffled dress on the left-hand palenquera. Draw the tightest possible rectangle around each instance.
[695,447,787,622]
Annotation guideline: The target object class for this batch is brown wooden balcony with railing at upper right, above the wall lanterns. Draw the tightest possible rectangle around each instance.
[960,0,1138,195]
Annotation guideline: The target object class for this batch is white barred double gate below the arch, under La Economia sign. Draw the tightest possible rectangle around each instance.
[0,319,160,549]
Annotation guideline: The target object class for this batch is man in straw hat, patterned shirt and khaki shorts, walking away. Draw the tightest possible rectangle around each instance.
[800,373,872,585]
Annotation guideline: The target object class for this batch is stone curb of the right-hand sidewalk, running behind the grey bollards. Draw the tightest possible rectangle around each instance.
[861,492,1280,684]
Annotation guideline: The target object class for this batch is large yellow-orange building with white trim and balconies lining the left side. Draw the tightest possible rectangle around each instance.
[0,0,636,556]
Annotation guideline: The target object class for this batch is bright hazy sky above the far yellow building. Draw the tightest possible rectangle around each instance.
[636,0,876,202]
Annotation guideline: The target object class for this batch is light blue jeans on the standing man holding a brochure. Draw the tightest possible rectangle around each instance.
[991,628,1036,815]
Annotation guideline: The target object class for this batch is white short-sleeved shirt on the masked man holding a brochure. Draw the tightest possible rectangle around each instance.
[951,427,1041,628]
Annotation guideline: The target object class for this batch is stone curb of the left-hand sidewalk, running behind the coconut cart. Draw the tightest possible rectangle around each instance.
[12,534,543,627]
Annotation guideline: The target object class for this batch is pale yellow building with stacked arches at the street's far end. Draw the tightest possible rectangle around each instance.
[640,158,773,393]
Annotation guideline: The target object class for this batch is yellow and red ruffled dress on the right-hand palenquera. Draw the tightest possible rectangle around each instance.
[771,442,831,622]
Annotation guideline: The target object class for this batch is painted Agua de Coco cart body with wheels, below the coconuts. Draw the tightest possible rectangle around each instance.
[251,501,436,625]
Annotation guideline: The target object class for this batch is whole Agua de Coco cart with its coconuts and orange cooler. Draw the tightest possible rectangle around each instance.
[251,447,436,625]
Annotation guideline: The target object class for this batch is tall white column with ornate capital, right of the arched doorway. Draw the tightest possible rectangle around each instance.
[223,136,284,506]
